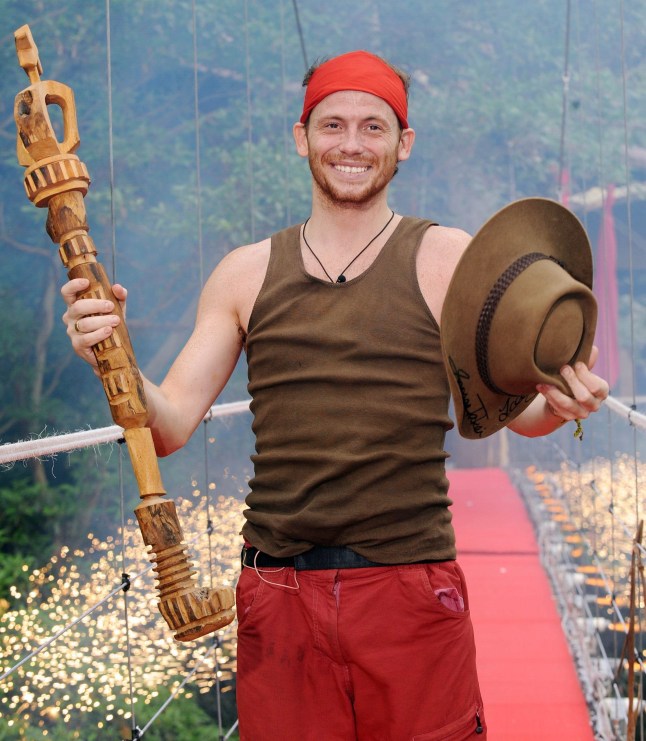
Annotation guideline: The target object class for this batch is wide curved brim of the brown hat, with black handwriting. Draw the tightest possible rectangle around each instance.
[440,198,596,439]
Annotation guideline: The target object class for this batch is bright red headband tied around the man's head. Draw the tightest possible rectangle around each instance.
[301,51,408,129]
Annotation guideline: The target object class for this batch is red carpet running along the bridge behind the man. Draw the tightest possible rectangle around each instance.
[449,468,594,741]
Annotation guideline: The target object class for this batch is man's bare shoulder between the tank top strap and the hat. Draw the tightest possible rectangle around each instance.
[417,226,471,323]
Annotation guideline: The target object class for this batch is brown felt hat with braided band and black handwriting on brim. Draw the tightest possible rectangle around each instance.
[441,198,597,438]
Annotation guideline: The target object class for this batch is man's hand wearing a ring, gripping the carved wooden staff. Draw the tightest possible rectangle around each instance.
[61,278,128,375]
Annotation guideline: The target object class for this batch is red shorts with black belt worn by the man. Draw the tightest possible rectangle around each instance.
[237,561,487,741]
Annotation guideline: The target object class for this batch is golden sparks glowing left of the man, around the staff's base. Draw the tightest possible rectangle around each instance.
[0,492,243,738]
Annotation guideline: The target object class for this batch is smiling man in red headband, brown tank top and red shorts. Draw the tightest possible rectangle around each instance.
[62,52,607,741]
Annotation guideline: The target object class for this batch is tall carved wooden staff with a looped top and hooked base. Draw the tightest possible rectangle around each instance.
[14,26,234,641]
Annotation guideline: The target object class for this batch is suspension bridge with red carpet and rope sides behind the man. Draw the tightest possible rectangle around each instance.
[0,0,646,741]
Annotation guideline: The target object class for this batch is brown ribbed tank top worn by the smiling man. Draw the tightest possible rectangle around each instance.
[242,217,455,564]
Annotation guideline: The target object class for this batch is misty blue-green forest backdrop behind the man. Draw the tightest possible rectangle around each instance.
[0,0,646,738]
